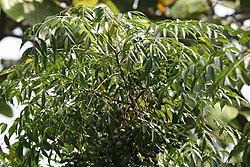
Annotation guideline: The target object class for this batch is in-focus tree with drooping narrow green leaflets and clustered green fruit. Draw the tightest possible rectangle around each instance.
[0,7,250,166]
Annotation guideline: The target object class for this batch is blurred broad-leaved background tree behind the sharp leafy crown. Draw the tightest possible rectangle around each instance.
[0,0,250,118]
